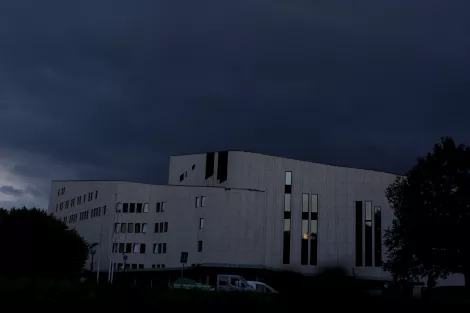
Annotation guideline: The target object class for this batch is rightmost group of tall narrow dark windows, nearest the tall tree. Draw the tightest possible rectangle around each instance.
[356,201,382,267]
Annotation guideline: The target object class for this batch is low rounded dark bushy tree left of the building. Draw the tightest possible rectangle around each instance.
[0,208,88,278]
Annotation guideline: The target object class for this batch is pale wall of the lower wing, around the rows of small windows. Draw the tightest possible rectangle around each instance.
[49,181,265,269]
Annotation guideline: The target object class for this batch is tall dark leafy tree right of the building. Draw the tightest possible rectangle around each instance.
[384,137,470,286]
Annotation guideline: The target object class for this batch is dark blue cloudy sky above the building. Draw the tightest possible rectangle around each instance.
[0,0,470,208]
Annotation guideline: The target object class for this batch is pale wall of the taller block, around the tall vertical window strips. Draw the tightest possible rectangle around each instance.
[169,151,396,278]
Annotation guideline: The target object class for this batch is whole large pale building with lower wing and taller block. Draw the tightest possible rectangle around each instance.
[49,151,396,278]
